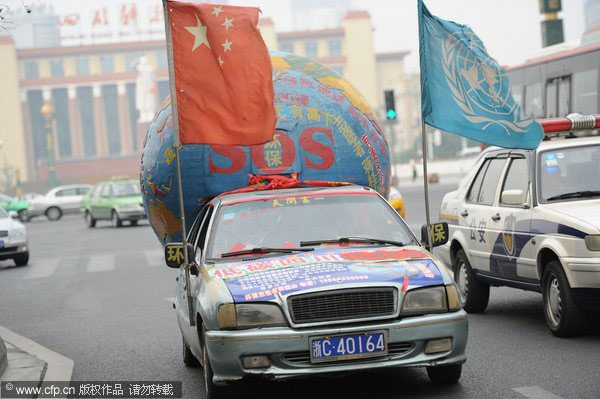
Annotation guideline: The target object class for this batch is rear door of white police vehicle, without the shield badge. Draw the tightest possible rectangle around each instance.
[459,158,508,272]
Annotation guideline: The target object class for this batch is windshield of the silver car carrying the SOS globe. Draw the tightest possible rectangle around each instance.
[206,193,414,258]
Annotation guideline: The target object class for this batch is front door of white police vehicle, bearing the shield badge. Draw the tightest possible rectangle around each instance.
[490,155,537,282]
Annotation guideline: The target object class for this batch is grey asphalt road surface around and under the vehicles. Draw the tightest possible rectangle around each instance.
[0,193,600,398]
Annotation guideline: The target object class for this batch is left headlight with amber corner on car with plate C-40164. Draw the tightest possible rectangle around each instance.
[219,303,287,329]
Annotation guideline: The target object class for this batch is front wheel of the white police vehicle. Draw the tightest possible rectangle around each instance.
[542,260,588,337]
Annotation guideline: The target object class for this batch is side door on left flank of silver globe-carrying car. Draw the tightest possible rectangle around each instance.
[175,205,212,347]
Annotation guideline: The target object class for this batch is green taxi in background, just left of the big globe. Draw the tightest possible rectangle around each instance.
[81,180,146,228]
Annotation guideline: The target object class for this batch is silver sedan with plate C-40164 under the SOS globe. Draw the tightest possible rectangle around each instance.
[165,186,467,398]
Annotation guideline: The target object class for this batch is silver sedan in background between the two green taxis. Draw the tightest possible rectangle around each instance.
[29,184,92,220]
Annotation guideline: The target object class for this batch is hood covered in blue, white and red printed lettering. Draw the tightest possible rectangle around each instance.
[209,247,444,302]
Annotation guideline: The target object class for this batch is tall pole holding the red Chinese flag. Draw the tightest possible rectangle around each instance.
[162,0,196,326]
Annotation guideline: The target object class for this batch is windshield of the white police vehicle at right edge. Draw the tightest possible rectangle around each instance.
[539,145,600,202]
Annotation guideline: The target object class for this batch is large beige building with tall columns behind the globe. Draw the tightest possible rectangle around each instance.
[0,11,412,188]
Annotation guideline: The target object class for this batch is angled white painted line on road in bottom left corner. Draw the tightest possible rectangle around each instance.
[0,326,73,381]
